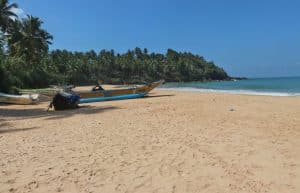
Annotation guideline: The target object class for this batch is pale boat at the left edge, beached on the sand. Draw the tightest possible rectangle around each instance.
[0,93,39,105]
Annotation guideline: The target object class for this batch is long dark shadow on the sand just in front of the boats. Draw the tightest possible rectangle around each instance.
[0,105,119,119]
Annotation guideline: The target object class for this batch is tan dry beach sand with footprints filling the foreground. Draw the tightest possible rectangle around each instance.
[0,91,300,193]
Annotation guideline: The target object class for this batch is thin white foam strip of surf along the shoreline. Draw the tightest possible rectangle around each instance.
[157,87,300,97]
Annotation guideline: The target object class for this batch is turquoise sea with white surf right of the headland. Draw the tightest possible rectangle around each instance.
[160,77,300,96]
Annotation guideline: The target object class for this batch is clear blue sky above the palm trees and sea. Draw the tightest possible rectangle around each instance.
[10,0,300,77]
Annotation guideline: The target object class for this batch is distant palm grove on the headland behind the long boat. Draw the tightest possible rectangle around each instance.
[41,48,229,85]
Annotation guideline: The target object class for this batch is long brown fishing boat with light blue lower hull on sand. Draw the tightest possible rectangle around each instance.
[76,80,164,103]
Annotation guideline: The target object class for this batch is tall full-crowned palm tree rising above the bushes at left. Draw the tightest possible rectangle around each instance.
[8,15,53,65]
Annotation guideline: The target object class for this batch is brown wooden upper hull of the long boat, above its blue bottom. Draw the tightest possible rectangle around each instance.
[77,80,164,99]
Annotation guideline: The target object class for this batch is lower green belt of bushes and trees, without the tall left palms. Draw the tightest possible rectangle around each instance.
[1,49,229,92]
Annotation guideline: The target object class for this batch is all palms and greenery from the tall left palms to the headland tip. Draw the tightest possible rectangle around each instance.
[0,0,229,92]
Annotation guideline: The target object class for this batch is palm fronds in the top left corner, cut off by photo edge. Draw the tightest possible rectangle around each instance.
[0,0,18,33]
